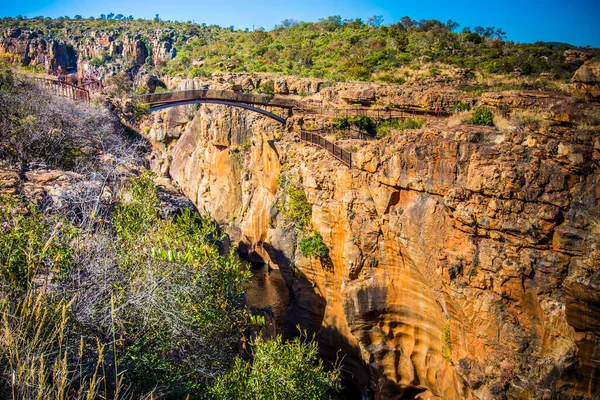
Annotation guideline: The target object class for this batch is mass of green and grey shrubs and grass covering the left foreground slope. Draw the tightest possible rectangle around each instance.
[0,69,339,400]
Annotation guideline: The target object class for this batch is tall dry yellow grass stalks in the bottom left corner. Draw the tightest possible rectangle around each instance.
[0,289,122,400]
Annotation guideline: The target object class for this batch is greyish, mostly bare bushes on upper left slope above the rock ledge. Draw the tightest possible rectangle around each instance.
[0,72,118,170]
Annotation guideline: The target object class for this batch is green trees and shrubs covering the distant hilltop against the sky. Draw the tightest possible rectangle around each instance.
[0,16,574,82]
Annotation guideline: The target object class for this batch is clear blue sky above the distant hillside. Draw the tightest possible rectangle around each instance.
[0,0,600,47]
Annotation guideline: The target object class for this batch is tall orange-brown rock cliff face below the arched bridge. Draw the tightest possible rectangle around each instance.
[148,83,600,399]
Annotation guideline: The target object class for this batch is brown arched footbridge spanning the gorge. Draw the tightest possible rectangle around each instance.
[134,89,298,124]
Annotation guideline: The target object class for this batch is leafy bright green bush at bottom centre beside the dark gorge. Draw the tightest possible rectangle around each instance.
[210,336,340,400]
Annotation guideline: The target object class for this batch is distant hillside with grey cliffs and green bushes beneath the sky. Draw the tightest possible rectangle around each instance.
[0,16,598,84]
